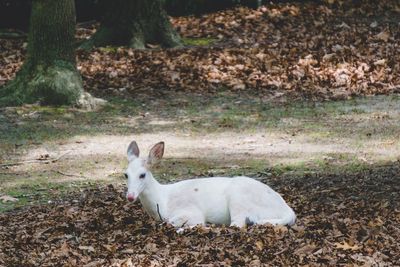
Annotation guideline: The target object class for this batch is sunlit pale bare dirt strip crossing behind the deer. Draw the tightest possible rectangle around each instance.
[1,96,400,189]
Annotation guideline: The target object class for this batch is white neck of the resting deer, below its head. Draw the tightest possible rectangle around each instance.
[139,175,167,220]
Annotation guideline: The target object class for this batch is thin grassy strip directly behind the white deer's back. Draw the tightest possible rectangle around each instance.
[153,156,376,182]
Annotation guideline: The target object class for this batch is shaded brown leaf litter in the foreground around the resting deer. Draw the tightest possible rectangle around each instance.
[0,164,400,266]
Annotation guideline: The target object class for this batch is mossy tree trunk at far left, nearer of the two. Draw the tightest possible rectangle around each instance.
[0,0,83,106]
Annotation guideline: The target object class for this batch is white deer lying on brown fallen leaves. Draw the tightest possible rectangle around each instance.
[125,141,296,227]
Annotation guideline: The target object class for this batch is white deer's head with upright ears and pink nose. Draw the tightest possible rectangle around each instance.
[125,141,164,201]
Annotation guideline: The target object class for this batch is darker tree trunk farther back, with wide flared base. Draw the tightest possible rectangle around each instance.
[81,0,182,49]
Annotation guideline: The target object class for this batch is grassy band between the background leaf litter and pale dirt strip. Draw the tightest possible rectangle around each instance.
[0,94,400,154]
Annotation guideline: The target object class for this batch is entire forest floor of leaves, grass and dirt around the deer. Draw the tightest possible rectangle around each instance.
[0,1,400,266]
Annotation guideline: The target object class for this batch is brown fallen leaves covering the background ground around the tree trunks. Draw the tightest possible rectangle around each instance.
[0,0,400,99]
